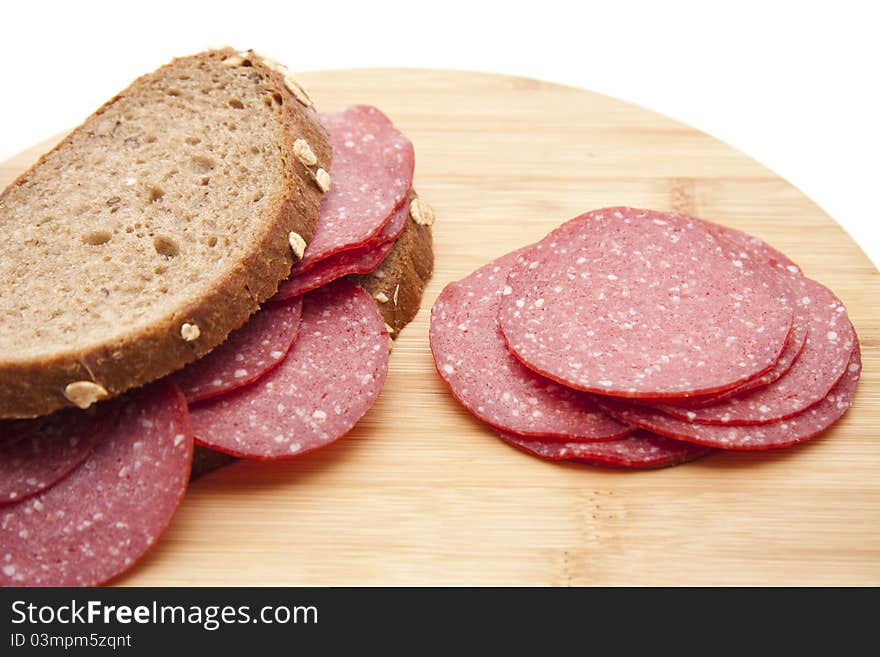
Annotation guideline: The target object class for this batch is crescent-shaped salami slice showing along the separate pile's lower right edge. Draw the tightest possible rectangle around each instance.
[600,343,862,450]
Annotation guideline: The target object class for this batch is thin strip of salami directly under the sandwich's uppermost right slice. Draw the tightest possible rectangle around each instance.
[272,197,409,301]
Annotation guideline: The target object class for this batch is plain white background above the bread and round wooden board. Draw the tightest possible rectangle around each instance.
[0,0,880,264]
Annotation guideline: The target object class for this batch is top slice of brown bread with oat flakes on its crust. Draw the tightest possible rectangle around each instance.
[0,49,331,418]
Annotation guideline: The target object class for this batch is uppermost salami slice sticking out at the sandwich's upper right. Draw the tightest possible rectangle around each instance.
[291,105,415,276]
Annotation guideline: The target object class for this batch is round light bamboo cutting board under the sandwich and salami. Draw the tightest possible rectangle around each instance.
[0,70,880,585]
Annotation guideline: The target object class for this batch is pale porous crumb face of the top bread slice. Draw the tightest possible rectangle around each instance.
[0,53,283,357]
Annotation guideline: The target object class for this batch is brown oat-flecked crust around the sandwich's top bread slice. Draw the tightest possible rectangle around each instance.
[0,48,331,418]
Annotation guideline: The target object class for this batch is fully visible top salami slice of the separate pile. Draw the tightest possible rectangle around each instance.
[499,208,793,398]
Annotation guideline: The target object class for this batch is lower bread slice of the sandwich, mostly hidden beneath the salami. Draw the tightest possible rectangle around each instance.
[191,191,434,479]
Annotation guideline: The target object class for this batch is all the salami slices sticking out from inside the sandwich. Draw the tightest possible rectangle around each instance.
[0,106,414,586]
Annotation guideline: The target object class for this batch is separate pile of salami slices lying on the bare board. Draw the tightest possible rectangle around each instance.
[430,208,861,468]
